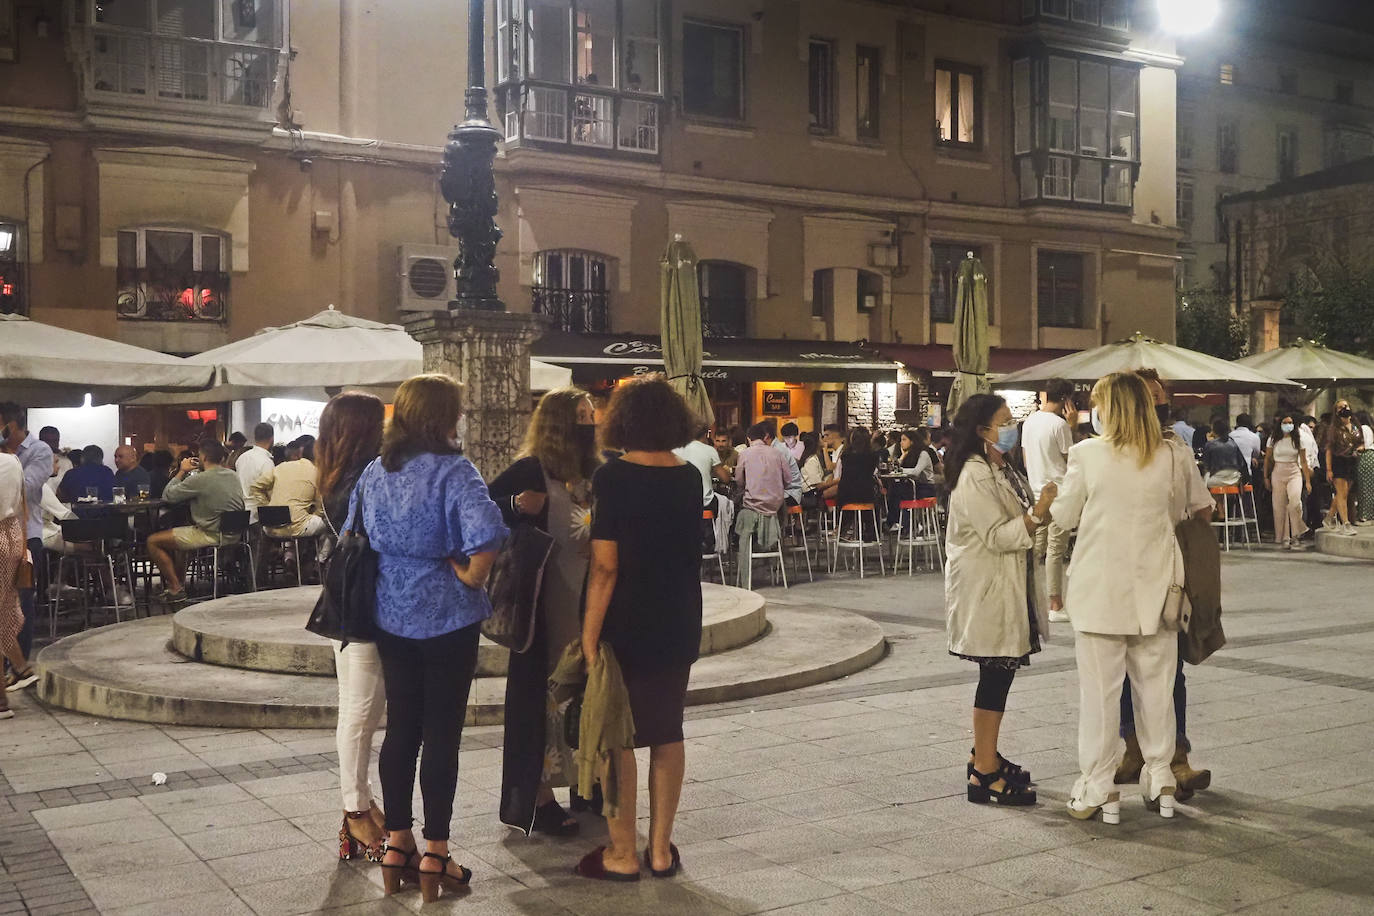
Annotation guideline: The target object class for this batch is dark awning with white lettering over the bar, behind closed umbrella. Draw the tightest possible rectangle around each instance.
[532,332,901,383]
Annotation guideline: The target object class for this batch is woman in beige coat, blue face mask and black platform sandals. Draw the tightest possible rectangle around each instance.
[944,394,1057,806]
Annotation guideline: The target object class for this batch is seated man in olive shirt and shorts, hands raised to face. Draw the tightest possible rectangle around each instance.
[148,442,243,602]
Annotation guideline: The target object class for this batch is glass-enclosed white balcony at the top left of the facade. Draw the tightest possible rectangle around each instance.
[71,0,282,122]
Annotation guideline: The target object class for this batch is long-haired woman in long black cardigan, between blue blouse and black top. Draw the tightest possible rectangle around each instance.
[491,387,600,836]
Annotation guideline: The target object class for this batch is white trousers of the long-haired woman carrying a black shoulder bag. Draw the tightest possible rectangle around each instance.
[331,640,386,812]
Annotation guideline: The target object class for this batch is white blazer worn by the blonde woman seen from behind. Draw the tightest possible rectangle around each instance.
[1050,438,1206,636]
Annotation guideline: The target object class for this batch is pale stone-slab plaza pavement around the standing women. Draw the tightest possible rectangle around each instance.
[0,549,1374,916]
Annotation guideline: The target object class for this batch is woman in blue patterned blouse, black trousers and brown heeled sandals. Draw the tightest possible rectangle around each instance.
[348,375,507,902]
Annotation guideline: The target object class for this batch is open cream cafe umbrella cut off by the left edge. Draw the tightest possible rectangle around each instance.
[0,314,210,407]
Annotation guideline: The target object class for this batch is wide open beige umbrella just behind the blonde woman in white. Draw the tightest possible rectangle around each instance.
[998,331,1303,394]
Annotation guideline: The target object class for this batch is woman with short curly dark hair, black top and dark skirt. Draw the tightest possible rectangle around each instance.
[578,378,703,880]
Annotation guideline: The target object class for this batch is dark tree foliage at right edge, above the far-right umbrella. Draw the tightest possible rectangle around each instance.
[1283,265,1374,356]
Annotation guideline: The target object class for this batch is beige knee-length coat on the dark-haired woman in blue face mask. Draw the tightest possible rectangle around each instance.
[945,456,1050,658]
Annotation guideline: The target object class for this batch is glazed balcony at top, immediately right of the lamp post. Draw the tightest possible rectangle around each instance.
[496,0,664,157]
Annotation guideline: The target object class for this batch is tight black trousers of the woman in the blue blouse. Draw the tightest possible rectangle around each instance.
[376,623,480,840]
